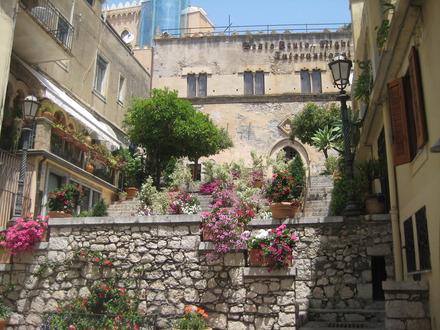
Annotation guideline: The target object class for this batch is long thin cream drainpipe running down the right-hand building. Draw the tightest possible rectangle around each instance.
[382,104,403,281]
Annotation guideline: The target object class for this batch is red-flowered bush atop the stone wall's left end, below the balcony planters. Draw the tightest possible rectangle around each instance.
[48,183,83,213]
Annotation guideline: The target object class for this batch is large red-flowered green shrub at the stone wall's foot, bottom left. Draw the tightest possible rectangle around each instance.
[48,280,142,330]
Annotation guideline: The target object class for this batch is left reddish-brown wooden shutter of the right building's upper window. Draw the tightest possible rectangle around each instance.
[388,78,411,166]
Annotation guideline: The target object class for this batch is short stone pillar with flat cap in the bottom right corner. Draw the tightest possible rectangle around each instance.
[382,281,431,330]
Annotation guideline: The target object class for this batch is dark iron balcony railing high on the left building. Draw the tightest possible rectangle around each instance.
[21,0,74,52]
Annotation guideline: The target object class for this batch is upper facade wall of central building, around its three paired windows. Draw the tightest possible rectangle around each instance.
[153,32,352,97]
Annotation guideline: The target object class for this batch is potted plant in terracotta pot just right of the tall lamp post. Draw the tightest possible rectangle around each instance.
[357,159,385,214]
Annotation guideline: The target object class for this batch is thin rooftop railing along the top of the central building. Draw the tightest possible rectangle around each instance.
[159,23,351,37]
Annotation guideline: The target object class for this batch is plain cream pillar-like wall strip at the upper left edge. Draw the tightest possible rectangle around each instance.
[0,0,18,132]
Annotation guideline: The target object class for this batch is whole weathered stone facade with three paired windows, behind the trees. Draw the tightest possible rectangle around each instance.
[153,31,352,176]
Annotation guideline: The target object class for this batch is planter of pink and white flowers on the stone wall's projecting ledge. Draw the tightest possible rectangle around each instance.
[247,224,299,270]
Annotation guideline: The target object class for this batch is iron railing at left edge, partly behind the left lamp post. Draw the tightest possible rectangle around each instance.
[0,150,34,228]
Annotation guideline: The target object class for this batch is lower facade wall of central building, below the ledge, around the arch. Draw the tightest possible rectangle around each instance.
[197,102,332,176]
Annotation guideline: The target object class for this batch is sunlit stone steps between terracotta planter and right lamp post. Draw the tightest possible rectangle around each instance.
[303,175,333,218]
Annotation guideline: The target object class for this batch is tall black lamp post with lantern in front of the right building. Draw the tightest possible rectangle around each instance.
[329,55,360,216]
